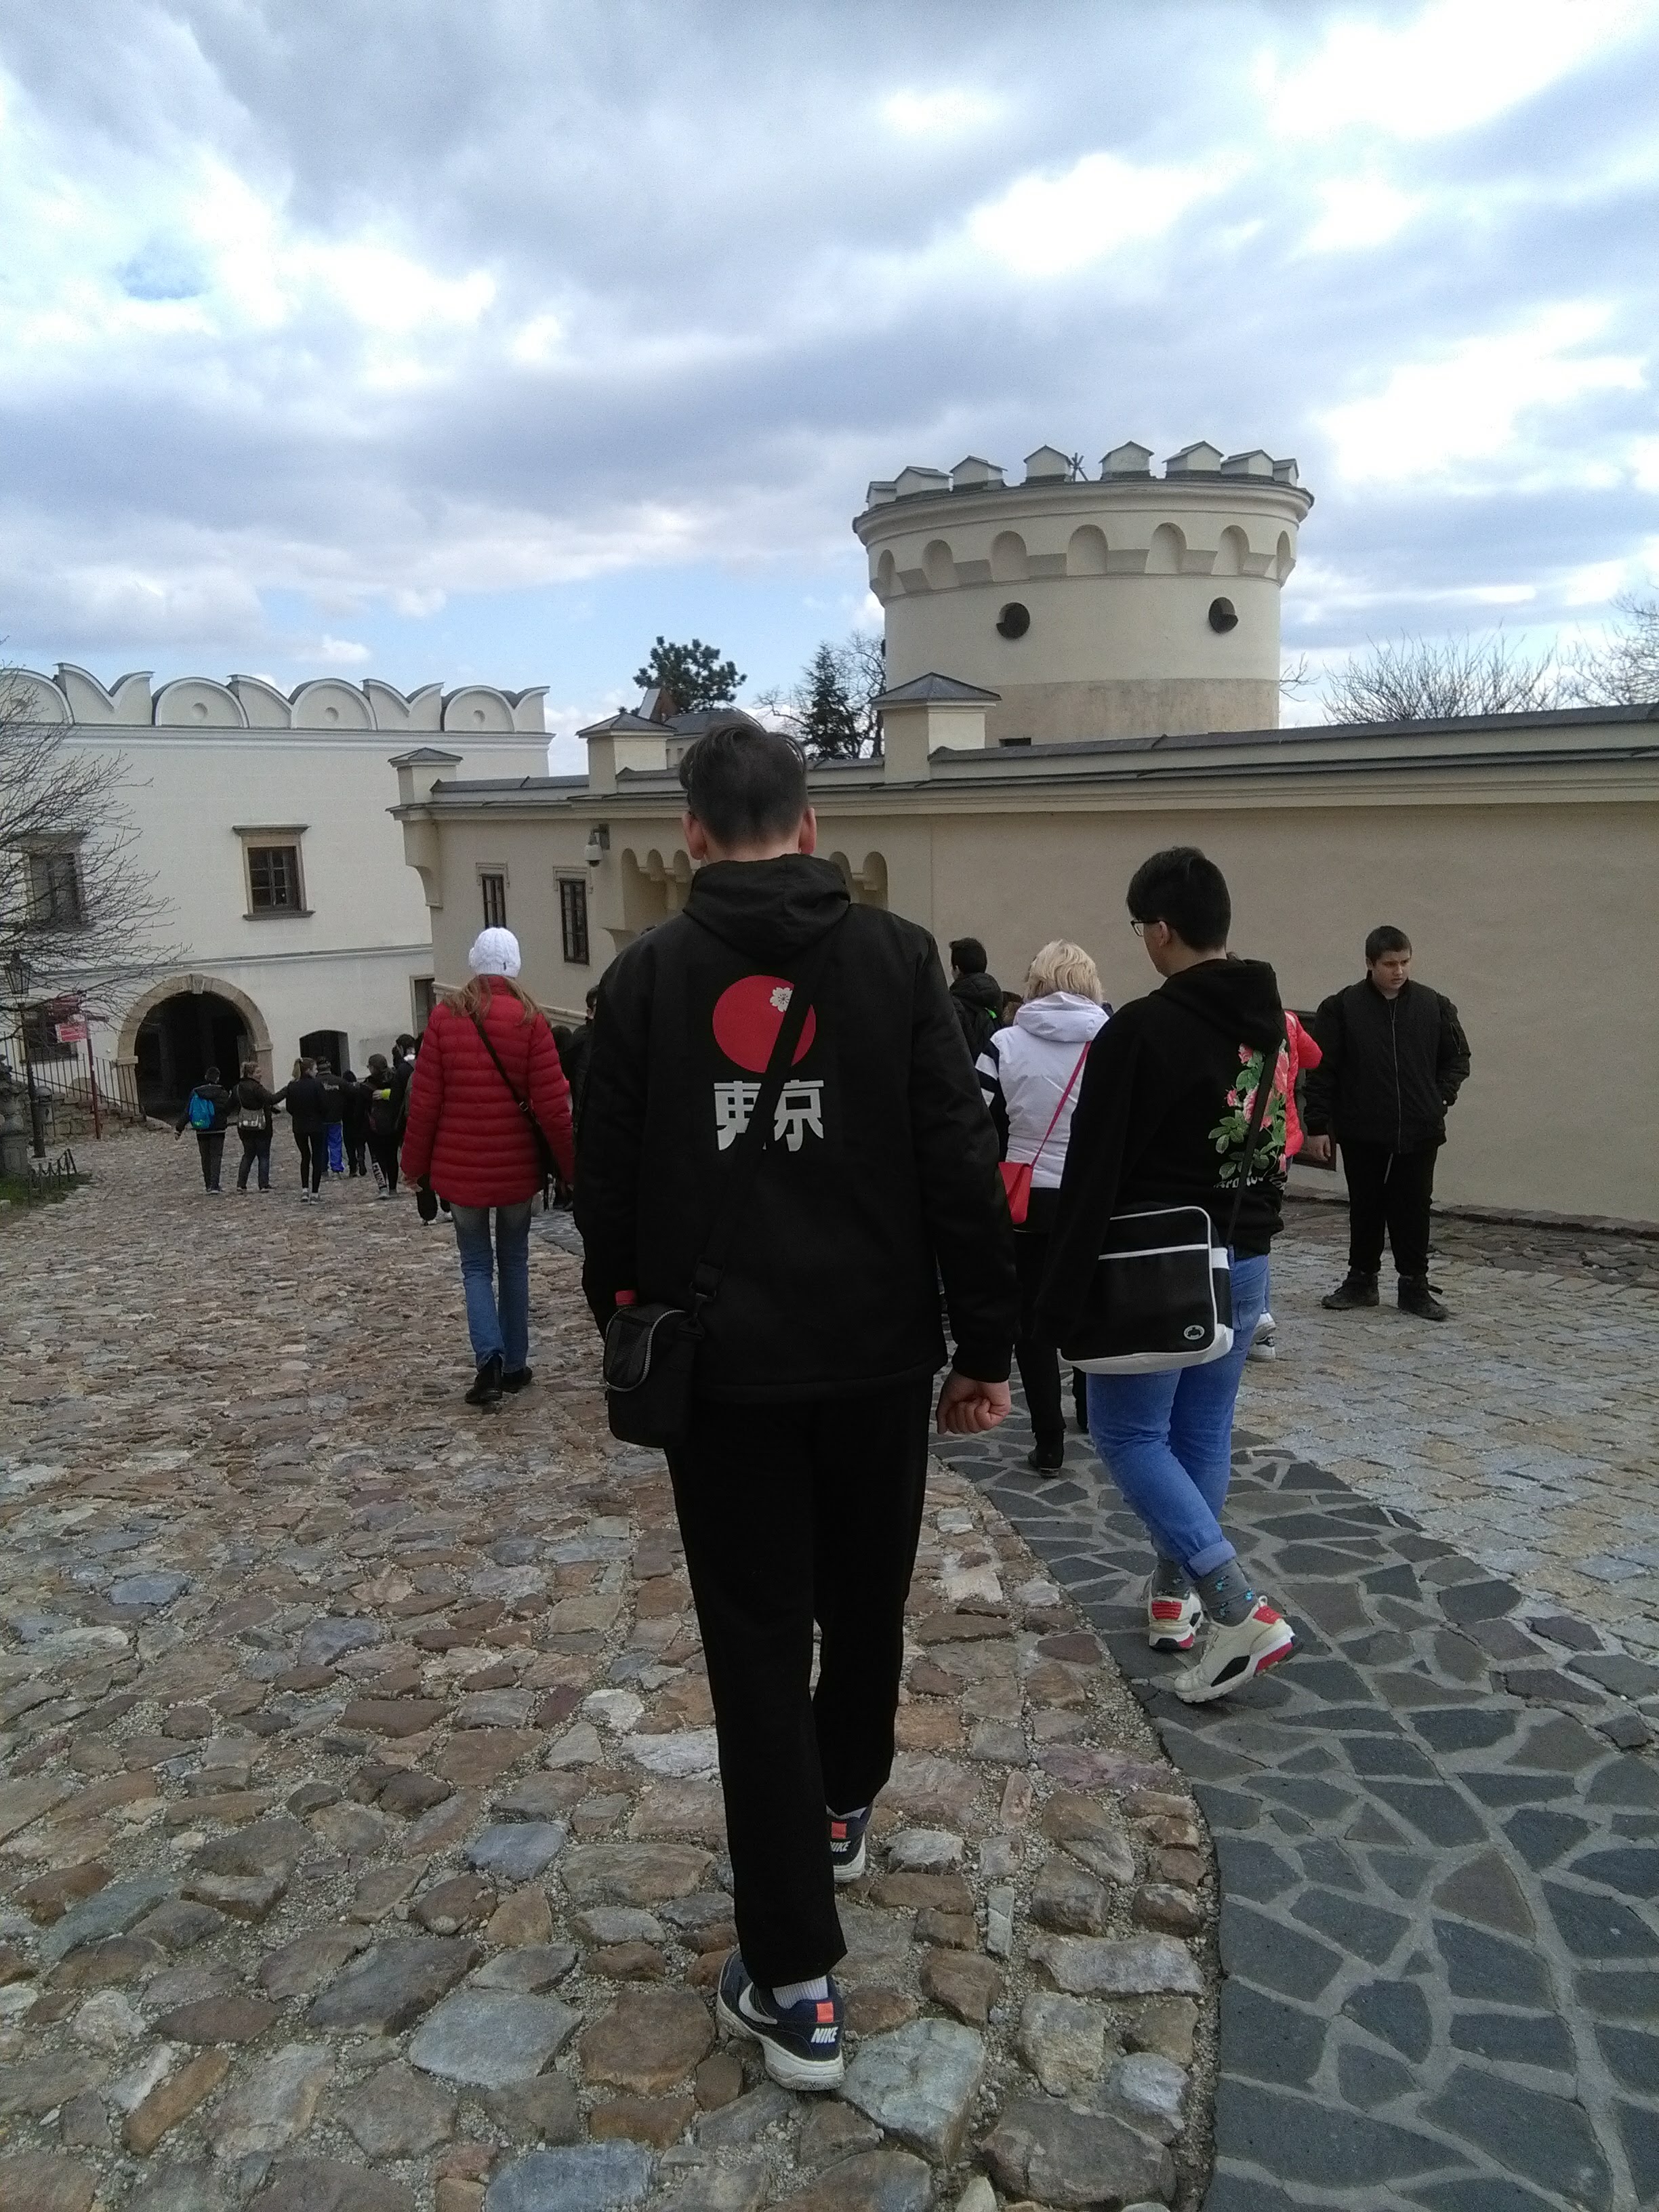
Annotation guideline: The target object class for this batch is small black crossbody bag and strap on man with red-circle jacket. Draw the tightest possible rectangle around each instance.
[604,922,840,1451]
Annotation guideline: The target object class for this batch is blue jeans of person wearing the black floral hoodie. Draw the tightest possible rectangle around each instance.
[1088,1254,1267,1575]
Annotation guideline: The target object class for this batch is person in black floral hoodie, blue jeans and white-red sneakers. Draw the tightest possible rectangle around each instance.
[1038,845,1296,1706]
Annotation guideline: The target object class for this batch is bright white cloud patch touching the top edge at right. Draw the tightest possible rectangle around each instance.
[1258,0,1652,140]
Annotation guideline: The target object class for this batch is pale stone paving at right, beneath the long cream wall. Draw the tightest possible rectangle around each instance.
[1246,1206,1659,1663]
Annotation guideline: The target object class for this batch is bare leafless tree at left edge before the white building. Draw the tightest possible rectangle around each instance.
[0,665,179,1013]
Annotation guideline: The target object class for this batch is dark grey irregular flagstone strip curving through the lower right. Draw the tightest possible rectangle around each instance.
[949,1353,1659,2212]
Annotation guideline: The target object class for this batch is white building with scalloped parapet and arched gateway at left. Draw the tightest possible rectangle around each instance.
[7,665,546,1108]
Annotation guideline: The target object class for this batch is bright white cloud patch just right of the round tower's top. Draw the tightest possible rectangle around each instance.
[1321,305,1643,485]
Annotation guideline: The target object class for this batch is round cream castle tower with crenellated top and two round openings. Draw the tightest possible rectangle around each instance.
[854,445,1314,745]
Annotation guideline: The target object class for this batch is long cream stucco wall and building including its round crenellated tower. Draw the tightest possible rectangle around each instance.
[396,447,1659,1221]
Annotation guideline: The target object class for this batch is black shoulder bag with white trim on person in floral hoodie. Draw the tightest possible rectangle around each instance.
[1059,1036,1285,1376]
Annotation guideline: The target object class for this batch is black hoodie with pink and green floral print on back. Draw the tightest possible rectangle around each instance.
[1038,960,1285,1338]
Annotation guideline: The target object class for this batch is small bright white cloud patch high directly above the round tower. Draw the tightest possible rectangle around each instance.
[966,152,1237,276]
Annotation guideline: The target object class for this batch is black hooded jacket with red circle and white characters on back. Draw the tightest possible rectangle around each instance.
[575,854,1015,1400]
